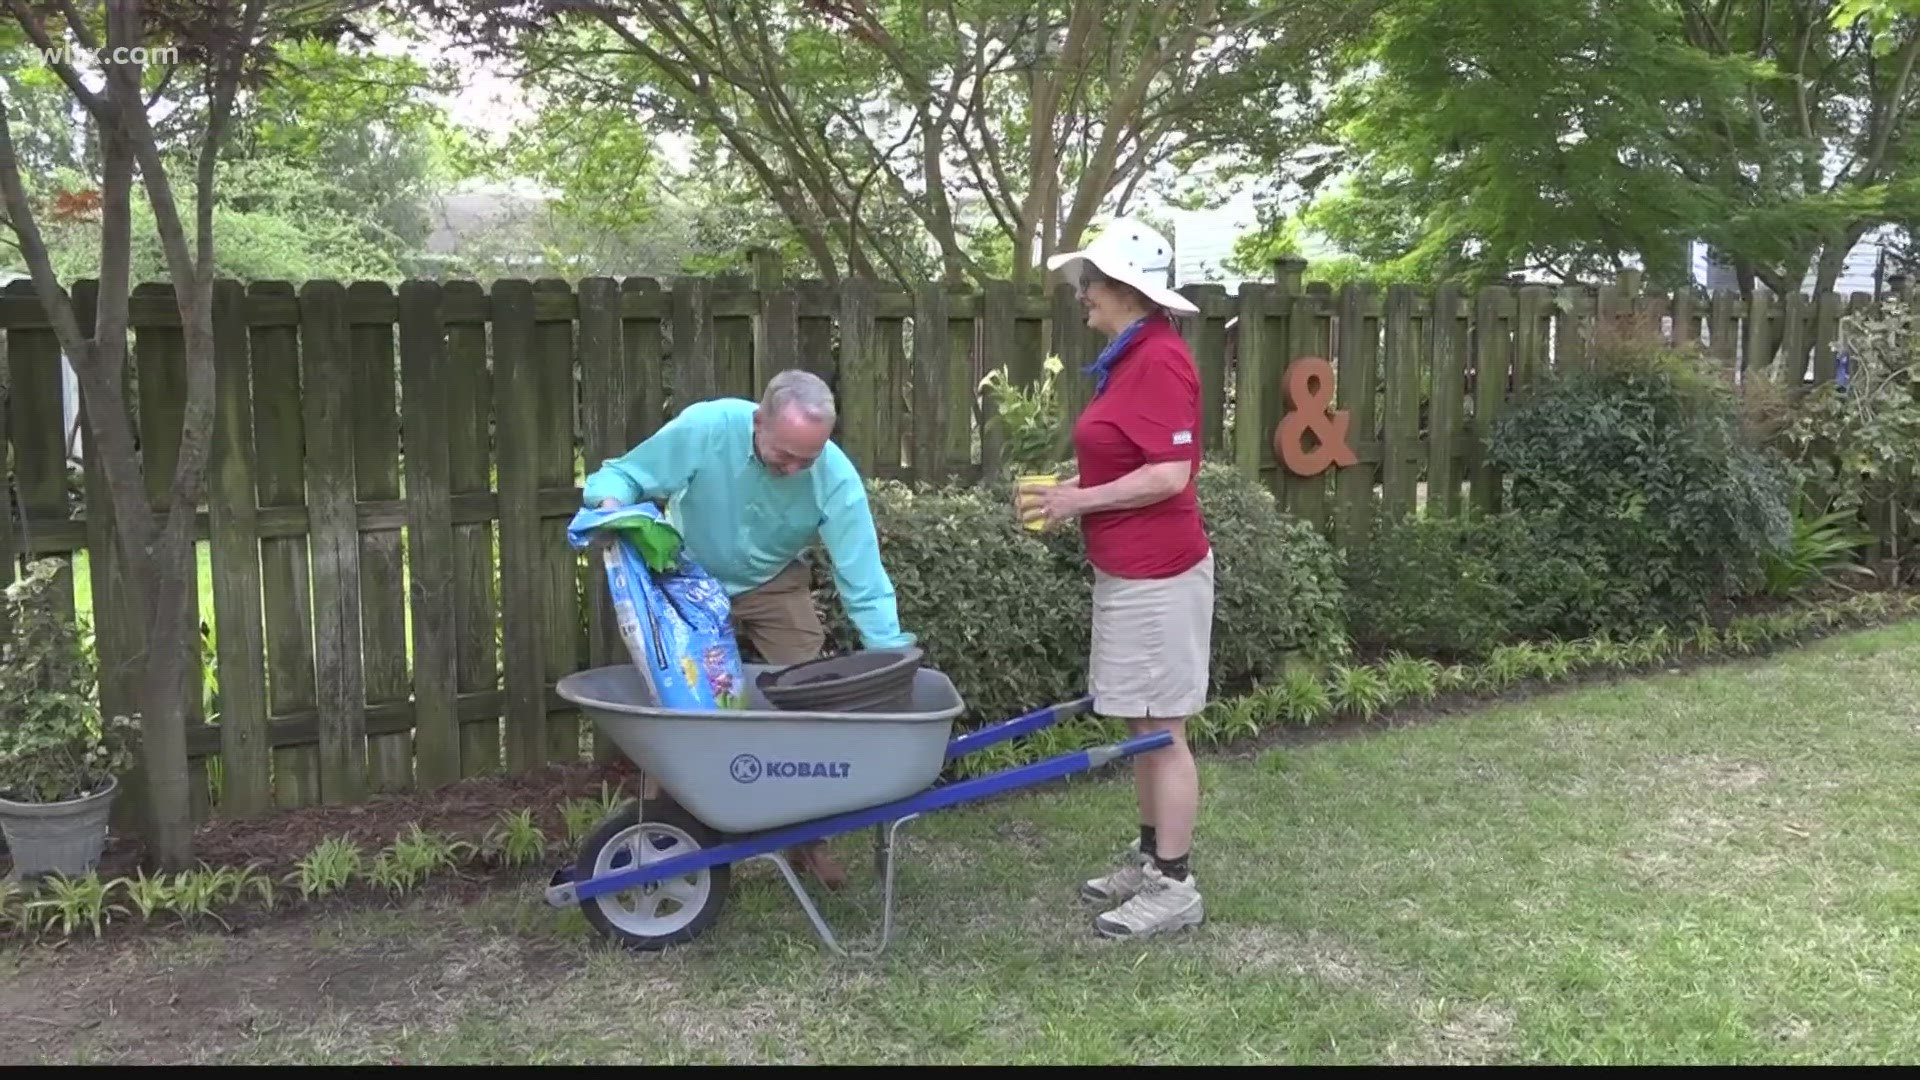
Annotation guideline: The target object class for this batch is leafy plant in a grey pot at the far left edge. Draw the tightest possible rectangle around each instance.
[0,559,136,878]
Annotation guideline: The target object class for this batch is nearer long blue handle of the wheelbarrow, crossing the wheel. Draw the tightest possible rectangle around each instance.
[547,722,1173,907]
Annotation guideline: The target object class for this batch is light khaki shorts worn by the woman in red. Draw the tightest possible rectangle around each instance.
[1087,552,1213,721]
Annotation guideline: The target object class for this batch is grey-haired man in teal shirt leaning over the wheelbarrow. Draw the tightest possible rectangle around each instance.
[582,371,914,884]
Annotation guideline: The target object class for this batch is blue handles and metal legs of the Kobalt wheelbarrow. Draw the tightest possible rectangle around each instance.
[545,696,1173,955]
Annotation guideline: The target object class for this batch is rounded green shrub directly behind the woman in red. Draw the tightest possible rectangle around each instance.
[814,455,1344,723]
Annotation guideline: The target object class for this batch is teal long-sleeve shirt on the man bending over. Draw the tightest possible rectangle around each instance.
[582,398,914,650]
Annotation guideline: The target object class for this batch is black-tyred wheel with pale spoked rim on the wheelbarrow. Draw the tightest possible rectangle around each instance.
[574,801,730,951]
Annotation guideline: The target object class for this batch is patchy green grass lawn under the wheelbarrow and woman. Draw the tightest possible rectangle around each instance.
[11,623,1920,1065]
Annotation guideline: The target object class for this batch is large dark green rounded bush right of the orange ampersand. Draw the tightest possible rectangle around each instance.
[1488,336,1791,626]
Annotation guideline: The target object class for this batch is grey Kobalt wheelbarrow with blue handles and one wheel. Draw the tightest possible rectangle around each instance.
[545,665,1173,955]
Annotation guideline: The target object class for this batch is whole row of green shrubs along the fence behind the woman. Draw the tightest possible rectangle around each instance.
[794,340,1873,723]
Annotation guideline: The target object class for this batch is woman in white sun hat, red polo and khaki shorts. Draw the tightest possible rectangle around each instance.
[1021,221,1213,938]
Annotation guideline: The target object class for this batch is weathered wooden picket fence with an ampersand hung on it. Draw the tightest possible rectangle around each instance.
[0,263,1870,834]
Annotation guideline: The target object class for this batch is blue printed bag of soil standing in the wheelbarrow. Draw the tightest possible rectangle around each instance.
[566,503,747,711]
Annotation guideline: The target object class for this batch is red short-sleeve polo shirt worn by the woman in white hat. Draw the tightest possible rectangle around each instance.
[1073,315,1208,578]
